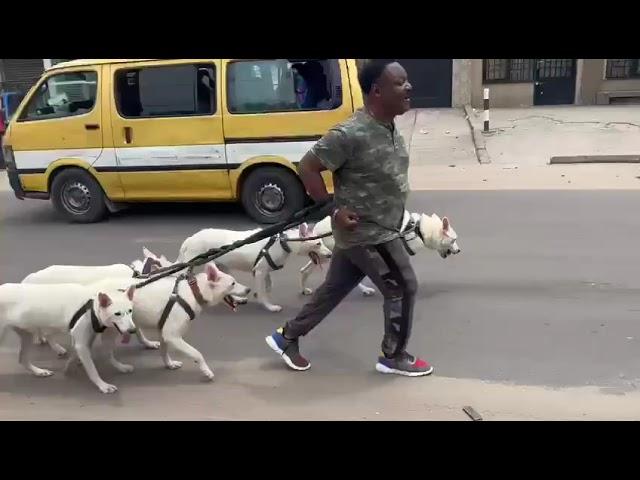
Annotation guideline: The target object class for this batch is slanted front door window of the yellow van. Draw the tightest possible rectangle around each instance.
[18,72,98,122]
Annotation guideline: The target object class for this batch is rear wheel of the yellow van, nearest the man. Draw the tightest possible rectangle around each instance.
[240,167,306,223]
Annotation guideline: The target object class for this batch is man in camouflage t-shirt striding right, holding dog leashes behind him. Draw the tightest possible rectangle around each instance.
[266,61,433,377]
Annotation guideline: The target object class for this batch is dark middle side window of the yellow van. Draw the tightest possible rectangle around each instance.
[115,64,216,118]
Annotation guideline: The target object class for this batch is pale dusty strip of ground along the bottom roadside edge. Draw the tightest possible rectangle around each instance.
[0,351,640,421]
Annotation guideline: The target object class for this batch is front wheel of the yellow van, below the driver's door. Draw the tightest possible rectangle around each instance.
[51,168,107,223]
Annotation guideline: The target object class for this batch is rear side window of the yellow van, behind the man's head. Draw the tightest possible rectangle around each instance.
[227,59,342,113]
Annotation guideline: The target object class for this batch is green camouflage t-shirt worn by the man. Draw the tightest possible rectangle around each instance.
[312,109,409,248]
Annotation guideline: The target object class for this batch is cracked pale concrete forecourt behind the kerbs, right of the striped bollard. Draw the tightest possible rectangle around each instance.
[470,105,640,166]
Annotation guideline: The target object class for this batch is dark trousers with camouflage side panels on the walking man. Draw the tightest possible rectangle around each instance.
[285,239,417,357]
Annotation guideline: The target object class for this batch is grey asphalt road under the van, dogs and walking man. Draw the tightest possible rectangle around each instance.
[0,191,640,415]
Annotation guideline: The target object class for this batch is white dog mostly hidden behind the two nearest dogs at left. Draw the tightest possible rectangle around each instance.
[22,247,172,357]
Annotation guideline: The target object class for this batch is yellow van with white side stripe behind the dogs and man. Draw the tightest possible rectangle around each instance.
[4,59,363,223]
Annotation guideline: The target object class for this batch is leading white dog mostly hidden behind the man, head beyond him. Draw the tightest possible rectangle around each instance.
[300,211,460,296]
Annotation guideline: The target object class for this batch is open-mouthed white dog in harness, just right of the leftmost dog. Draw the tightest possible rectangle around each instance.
[68,262,240,380]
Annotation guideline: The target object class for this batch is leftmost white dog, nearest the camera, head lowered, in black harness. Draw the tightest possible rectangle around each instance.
[0,283,135,393]
